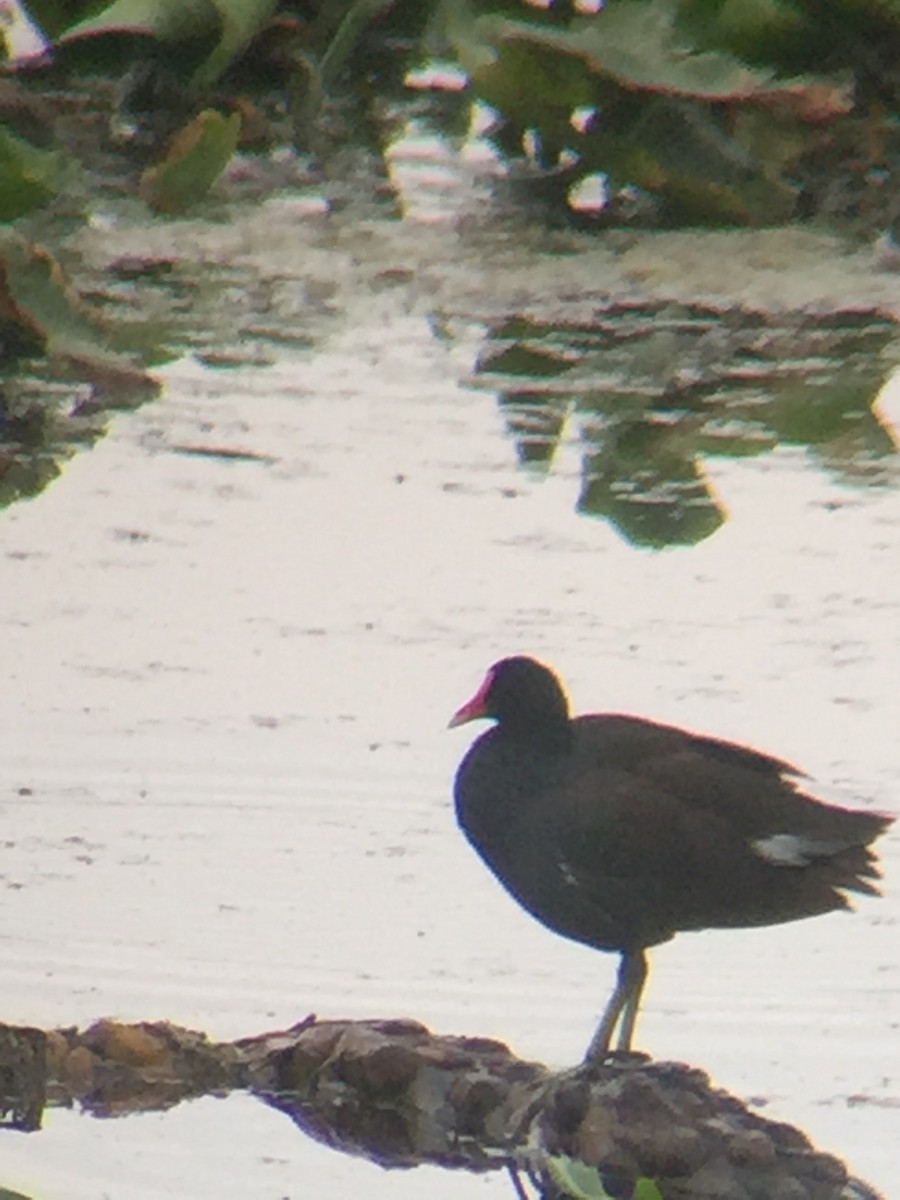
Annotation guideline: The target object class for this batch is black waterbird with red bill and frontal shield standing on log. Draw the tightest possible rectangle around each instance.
[450,655,894,1062]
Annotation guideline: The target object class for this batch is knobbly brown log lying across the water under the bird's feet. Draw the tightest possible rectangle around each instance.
[0,1018,877,1200]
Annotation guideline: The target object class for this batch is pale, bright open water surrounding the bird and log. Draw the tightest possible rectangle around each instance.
[0,126,900,1200]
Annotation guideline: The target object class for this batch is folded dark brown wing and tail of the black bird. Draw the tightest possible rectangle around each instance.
[559,718,890,929]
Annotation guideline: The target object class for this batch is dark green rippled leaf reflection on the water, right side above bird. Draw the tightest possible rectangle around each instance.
[476,304,900,547]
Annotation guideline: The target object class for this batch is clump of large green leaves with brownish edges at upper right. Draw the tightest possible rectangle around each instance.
[445,0,900,224]
